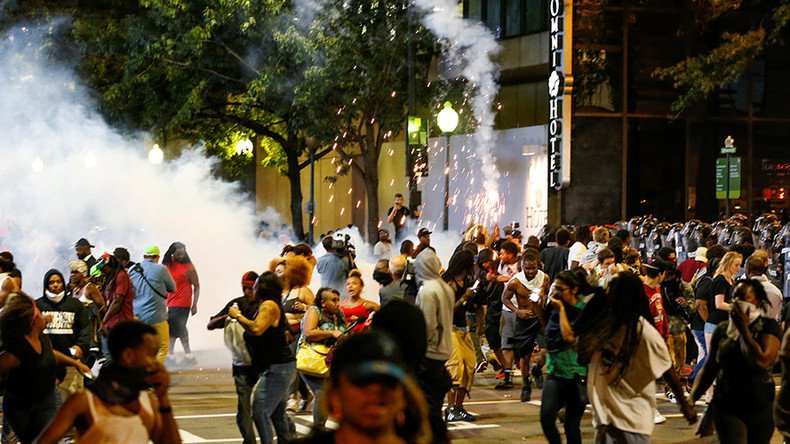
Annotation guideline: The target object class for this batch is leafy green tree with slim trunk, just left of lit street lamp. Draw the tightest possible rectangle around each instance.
[301,0,436,243]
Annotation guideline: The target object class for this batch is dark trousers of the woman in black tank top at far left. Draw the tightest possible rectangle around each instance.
[3,384,60,444]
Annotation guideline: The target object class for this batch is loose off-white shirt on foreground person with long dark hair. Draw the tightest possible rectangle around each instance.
[587,318,672,436]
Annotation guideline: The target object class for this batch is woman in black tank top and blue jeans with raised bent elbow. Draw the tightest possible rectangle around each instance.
[228,271,296,442]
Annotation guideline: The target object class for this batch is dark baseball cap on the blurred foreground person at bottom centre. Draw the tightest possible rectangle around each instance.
[330,331,407,386]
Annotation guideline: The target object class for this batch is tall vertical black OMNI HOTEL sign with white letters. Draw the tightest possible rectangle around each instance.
[548,0,573,190]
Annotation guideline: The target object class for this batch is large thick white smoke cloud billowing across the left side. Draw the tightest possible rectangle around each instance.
[0,27,288,354]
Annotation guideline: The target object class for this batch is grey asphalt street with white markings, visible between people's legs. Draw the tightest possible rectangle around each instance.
[164,360,781,443]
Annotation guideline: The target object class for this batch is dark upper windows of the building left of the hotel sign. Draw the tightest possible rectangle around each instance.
[464,0,548,39]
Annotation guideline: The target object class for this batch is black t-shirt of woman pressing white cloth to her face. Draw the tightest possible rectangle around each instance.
[709,317,782,413]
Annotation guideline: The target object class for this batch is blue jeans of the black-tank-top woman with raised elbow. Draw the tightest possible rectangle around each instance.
[252,361,296,443]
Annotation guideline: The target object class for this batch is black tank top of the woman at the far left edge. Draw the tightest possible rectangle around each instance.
[5,333,57,404]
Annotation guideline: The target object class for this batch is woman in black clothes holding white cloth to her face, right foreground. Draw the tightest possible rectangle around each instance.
[689,279,781,444]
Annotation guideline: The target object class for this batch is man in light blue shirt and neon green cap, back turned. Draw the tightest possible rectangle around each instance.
[129,245,176,363]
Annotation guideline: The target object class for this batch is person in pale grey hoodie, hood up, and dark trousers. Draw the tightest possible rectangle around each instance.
[414,248,455,442]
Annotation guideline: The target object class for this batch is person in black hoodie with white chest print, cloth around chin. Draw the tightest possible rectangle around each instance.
[36,269,92,399]
